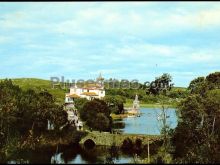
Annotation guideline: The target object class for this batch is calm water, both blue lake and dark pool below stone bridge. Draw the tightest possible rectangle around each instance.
[8,108,177,164]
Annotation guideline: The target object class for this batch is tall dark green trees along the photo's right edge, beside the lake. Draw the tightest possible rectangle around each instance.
[173,72,220,163]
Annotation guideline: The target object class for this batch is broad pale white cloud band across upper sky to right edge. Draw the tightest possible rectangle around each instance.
[49,2,220,37]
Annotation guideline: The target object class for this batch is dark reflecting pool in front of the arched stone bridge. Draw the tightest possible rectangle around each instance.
[7,145,136,164]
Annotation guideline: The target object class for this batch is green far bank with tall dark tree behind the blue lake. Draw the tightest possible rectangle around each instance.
[106,73,189,104]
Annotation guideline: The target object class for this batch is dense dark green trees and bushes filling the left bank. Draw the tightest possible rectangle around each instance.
[0,79,83,162]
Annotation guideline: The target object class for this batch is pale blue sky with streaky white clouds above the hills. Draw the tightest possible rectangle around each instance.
[0,2,220,87]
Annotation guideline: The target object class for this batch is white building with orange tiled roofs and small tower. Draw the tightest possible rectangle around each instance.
[65,74,105,103]
